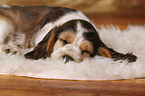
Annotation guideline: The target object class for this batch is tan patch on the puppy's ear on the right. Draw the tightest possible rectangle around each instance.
[98,47,112,58]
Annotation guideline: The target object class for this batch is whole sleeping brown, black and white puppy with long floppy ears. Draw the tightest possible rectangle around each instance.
[0,5,137,62]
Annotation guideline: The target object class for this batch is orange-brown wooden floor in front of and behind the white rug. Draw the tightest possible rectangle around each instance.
[0,15,145,96]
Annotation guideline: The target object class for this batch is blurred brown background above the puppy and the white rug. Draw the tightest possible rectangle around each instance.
[0,0,145,25]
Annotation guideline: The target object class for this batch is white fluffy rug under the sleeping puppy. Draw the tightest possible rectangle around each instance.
[0,26,145,80]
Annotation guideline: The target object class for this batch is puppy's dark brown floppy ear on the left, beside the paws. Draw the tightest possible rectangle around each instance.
[24,32,56,60]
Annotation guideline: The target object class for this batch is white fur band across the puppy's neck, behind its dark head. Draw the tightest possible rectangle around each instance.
[35,11,90,44]
